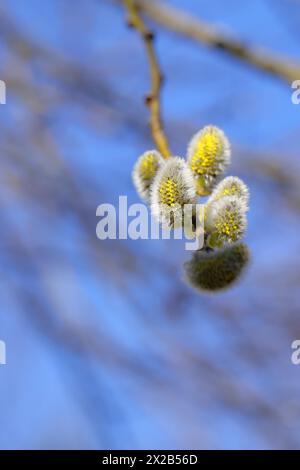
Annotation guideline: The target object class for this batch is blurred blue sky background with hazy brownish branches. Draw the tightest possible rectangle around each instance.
[0,0,300,449]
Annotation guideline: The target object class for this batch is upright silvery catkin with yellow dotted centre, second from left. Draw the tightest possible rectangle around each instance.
[150,157,197,228]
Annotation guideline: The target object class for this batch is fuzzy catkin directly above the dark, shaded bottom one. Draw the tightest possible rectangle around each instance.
[205,196,247,248]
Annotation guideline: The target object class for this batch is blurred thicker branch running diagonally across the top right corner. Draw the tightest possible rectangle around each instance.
[136,0,300,83]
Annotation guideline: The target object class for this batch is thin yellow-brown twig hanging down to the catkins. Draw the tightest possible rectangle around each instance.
[124,0,171,158]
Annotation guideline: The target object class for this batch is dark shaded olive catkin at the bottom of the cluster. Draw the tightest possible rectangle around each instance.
[184,243,250,292]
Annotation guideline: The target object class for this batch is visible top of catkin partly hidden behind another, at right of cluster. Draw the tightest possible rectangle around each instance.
[207,176,249,209]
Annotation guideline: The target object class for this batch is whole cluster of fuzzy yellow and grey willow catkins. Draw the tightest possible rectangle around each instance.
[133,126,249,291]
